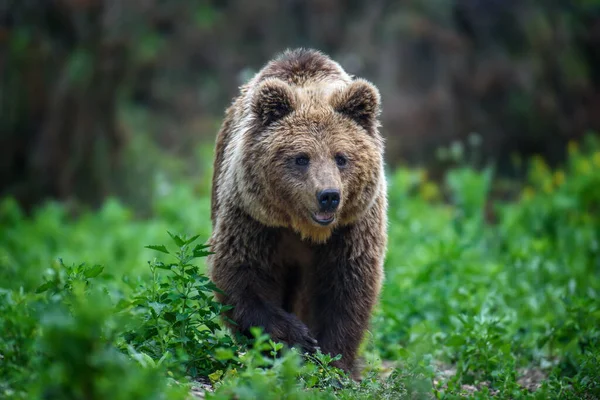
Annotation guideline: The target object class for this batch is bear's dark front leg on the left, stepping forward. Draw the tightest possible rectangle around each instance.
[209,207,316,351]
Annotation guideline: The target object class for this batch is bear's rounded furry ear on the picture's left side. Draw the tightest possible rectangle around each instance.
[252,78,296,126]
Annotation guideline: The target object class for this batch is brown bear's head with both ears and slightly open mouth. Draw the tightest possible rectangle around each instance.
[238,78,385,243]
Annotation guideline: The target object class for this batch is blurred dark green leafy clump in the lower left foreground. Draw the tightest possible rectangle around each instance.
[30,286,185,399]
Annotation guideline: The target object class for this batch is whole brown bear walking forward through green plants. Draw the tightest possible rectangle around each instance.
[208,49,387,376]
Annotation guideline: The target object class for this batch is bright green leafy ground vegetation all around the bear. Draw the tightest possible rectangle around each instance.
[0,139,600,399]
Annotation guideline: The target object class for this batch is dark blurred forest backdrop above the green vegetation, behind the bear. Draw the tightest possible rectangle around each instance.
[0,0,600,208]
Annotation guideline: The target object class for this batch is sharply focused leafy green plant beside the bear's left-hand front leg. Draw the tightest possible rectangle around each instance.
[126,234,236,377]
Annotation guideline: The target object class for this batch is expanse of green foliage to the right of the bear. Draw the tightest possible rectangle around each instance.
[373,137,600,398]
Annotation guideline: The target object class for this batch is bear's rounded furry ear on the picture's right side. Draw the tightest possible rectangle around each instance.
[331,79,381,133]
